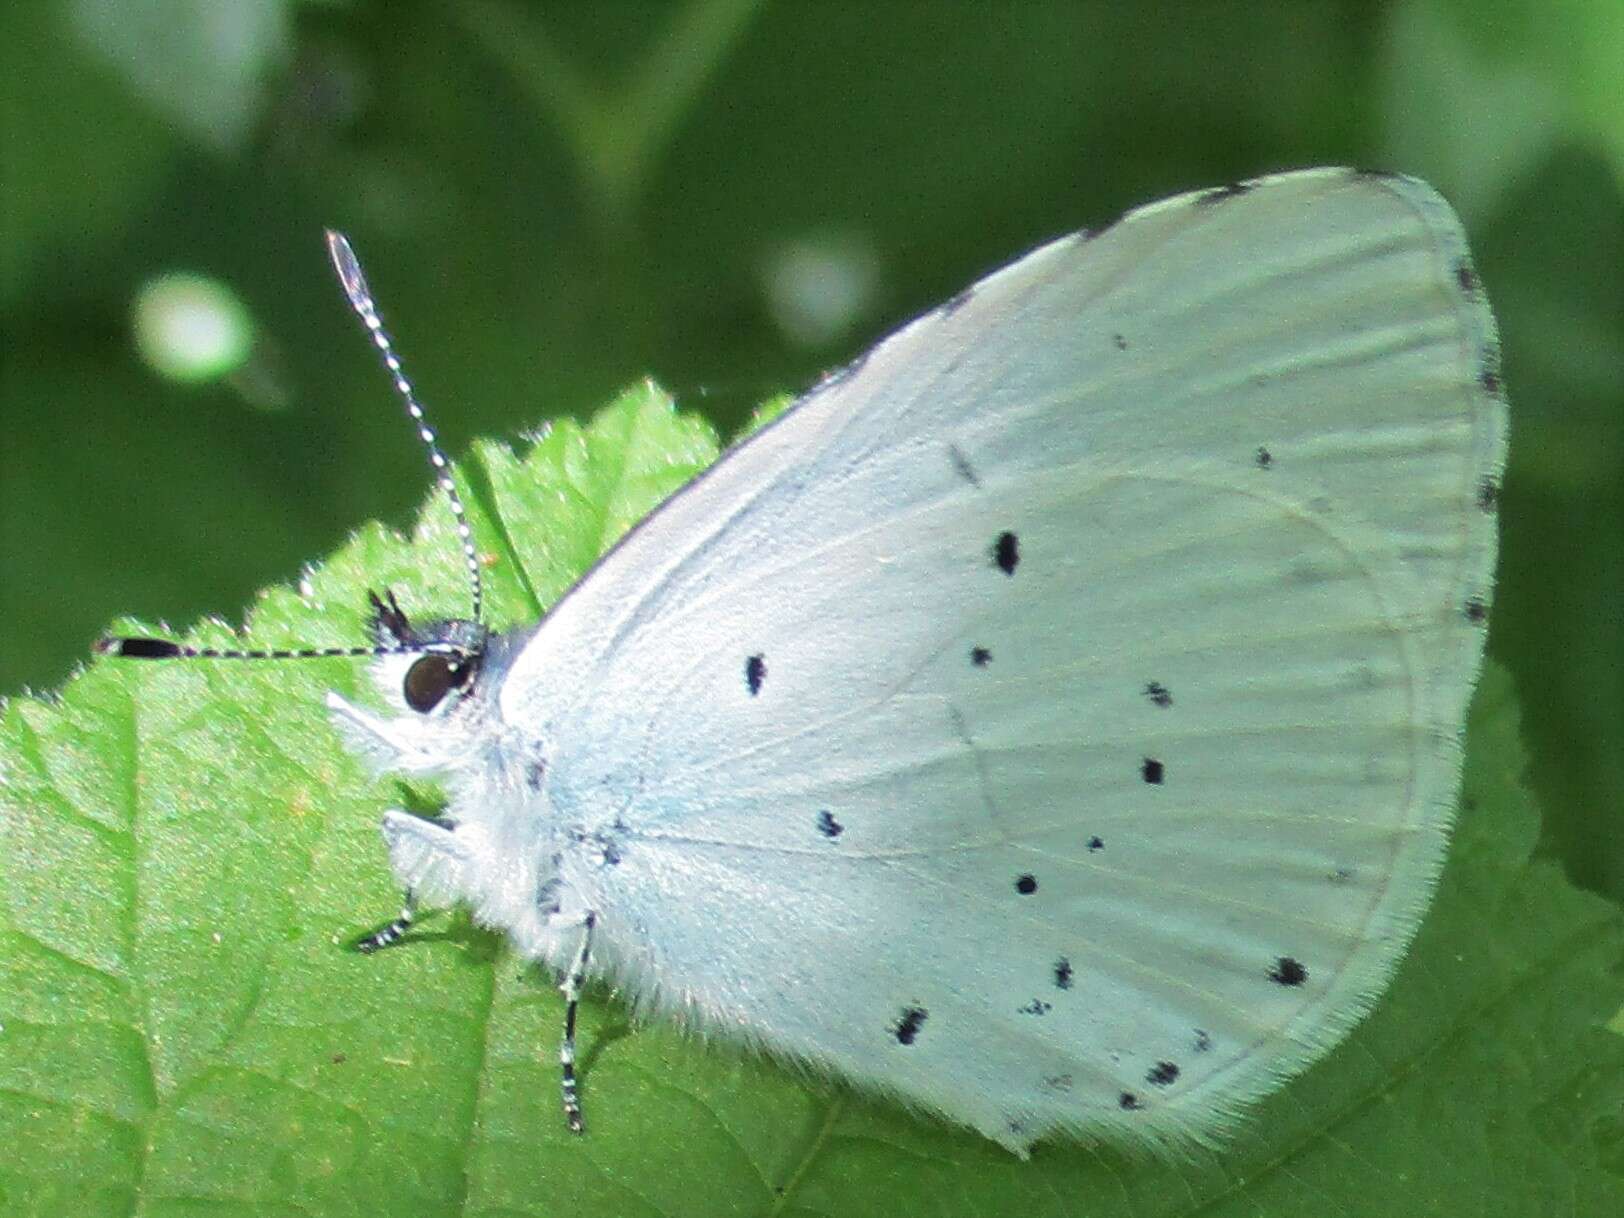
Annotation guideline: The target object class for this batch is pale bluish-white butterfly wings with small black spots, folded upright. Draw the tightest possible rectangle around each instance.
[500,171,1505,1151]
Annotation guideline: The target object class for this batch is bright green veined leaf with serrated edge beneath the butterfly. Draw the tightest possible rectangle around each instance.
[0,385,1624,1218]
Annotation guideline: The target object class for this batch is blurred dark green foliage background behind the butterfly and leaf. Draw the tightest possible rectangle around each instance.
[0,0,1624,928]
